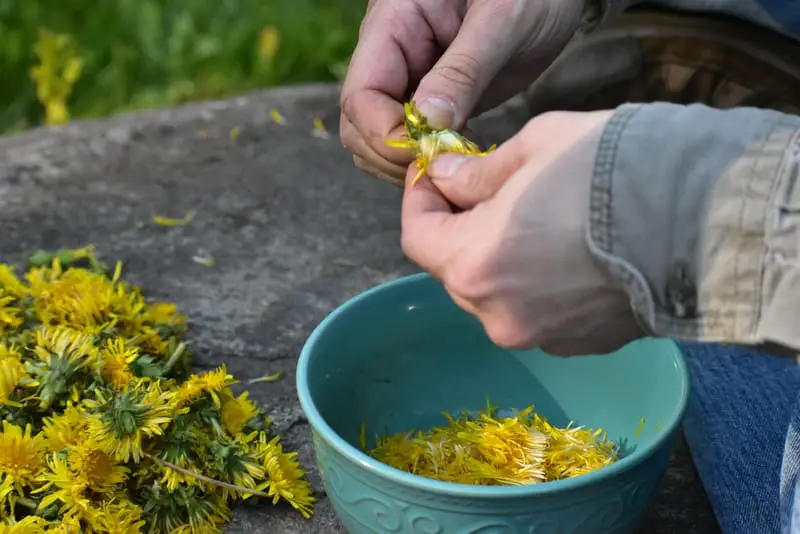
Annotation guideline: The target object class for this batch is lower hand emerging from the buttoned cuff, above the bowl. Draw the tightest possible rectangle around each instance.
[402,111,642,355]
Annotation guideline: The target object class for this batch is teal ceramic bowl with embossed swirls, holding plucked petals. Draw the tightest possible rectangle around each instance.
[297,275,689,534]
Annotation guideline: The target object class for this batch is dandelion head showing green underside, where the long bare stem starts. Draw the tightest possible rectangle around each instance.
[84,381,174,462]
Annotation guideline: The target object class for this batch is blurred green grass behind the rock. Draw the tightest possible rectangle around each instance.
[0,0,366,133]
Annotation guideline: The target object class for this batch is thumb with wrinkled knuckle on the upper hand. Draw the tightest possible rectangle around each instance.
[414,1,514,128]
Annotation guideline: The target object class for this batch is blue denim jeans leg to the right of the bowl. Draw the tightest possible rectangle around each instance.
[681,343,800,534]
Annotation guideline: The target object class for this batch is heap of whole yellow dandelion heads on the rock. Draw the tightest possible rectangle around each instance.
[0,247,314,534]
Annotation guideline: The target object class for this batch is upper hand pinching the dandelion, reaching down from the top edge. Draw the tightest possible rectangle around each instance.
[340,0,585,184]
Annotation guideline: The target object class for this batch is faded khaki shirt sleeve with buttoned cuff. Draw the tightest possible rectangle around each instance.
[587,103,800,349]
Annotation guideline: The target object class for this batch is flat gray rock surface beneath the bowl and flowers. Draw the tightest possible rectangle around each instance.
[0,86,719,534]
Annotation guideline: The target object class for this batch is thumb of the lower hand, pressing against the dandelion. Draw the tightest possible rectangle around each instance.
[427,135,528,210]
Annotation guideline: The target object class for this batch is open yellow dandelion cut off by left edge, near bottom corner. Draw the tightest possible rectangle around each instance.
[0,421,47,508]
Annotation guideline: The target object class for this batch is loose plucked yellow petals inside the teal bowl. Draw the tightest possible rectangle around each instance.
[361,404,618,486]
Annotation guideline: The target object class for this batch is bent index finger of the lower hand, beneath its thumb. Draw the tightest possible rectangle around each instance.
[401,167,468,280]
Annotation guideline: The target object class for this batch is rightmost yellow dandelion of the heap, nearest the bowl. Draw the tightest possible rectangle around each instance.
[254,432,316,518]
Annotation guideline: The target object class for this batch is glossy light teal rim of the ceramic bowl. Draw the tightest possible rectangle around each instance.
[296,272,690,499]
